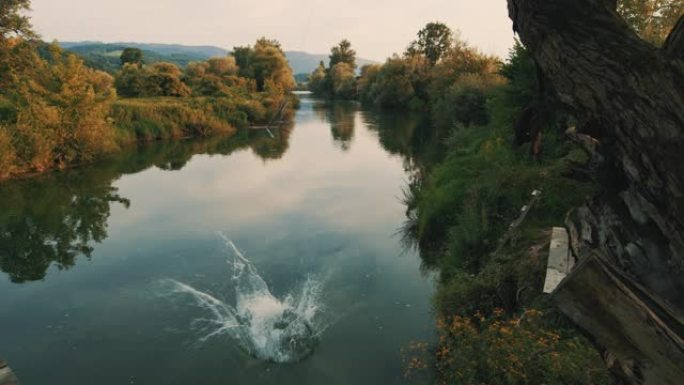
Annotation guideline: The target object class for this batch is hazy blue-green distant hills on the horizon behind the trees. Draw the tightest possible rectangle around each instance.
[59,41,376,74]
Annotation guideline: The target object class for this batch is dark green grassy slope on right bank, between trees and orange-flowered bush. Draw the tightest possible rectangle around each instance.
[414,123,593,313]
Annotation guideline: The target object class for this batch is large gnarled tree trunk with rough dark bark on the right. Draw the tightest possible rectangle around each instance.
[508,0,684,382]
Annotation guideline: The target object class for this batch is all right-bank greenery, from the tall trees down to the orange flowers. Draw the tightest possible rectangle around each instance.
[380,21,610,384]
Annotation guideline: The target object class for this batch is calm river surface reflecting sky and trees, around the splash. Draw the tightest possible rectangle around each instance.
[0,97,433,385]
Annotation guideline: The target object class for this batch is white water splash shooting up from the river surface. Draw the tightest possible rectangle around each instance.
[170,236,326,363]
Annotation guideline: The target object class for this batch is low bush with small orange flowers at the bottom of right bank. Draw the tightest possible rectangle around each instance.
[436,310,612,385]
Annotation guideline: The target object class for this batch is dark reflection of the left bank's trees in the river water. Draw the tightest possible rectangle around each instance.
[0,129,292,283]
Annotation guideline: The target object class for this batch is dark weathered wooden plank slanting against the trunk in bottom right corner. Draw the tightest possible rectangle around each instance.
[551,253,684,385]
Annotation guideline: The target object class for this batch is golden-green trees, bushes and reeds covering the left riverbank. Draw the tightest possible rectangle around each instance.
[0,0,294,179]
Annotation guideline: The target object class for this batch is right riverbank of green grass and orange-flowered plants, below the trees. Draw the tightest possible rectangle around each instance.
[398,110,611,384]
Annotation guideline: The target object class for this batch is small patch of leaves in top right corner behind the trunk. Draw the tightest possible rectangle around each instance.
[617,0,684,45]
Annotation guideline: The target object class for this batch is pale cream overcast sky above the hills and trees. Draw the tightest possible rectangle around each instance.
[32,0,513,60]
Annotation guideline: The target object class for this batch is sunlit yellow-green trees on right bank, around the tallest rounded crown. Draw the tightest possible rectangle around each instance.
[358,23,503,130]
